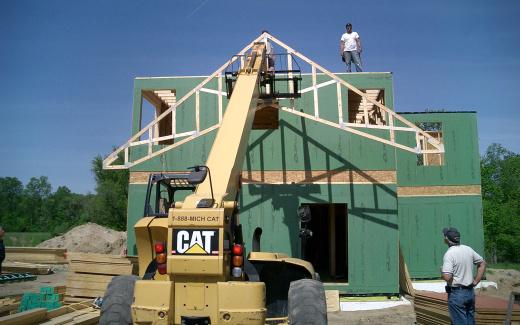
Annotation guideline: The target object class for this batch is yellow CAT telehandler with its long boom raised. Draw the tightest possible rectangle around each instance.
[100,42,327,325]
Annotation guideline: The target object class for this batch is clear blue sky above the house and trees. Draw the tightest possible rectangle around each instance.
[0,0,520,193]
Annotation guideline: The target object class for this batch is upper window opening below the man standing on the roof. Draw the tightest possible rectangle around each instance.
[348,89,387,125]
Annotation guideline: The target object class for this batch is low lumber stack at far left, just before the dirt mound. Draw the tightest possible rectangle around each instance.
[5,247,67,264]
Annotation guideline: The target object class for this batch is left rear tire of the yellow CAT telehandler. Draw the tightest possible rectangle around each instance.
[99,275,138,325]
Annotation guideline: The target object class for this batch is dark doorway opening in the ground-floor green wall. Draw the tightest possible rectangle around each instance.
[302,203,348,282]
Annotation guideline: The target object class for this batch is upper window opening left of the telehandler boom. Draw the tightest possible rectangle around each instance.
[141,89,177,144]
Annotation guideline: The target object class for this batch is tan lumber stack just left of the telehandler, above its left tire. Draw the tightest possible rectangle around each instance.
[65,253,133,302]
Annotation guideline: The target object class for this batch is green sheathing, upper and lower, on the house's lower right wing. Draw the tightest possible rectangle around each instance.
[397,113,484,278]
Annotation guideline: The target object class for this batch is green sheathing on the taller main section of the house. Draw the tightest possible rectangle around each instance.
[124,73,398,293]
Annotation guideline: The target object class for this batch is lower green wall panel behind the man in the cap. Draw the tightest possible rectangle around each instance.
[398,196,484,278]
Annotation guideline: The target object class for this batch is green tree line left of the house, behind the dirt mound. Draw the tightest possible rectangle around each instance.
[0,156,128,235]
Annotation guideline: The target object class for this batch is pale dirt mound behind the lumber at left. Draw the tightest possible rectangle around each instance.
[38,222,126,255]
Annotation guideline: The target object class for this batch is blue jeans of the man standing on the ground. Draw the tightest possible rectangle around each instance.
[448,288,475,325]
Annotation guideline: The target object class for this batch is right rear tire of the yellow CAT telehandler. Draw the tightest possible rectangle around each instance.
[288,279,327,325]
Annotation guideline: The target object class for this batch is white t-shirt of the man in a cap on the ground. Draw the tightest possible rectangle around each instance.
[442,245,484,286]
